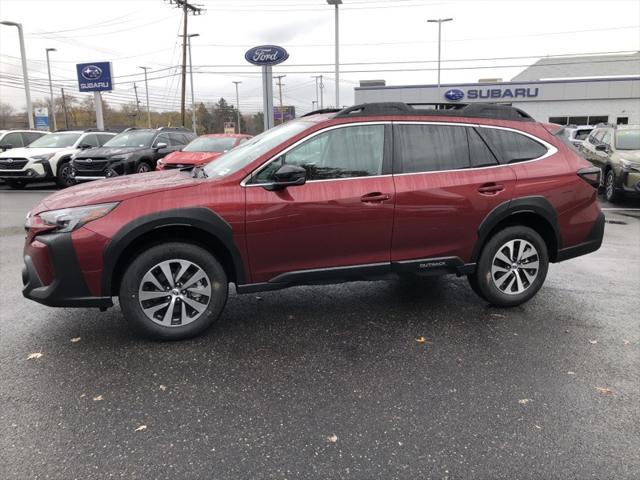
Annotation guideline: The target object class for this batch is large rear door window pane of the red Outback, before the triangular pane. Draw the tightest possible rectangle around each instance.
[393,124,469,173]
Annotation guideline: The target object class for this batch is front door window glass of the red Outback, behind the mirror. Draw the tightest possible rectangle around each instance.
[252,125,384,183]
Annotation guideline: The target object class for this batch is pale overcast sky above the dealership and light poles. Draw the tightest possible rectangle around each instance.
[0,0,640,113]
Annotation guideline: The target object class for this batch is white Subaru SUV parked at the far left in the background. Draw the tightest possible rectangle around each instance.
[0,129,115,188]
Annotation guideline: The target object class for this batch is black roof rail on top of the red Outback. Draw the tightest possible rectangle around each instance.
[334,102,534,122]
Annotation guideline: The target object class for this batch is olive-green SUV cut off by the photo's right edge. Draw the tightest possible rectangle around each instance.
[580,125,640,203]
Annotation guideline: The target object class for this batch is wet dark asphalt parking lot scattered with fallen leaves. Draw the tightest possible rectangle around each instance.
[0,185,640,479]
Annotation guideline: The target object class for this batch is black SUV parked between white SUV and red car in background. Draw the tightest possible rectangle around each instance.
[73,127,196,182]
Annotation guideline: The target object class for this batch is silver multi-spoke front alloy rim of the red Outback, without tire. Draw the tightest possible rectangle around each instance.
[138,259,211,327]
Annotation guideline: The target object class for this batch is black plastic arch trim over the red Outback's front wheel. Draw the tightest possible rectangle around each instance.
[102,207,246,295]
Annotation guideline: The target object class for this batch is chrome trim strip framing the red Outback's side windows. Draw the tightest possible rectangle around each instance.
[240,120,558,187]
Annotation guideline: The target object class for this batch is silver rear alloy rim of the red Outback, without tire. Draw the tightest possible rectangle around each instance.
[491,238,540,295]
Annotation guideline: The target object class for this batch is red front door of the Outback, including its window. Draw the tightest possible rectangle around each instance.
[245,122,394,283]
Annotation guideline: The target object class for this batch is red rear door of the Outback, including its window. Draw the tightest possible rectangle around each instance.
[391,122,516,271]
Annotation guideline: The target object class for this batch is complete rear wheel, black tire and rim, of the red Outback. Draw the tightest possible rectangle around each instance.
[469,225,549,307]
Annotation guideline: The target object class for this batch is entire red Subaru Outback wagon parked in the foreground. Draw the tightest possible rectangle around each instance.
[23,103,604,339]
